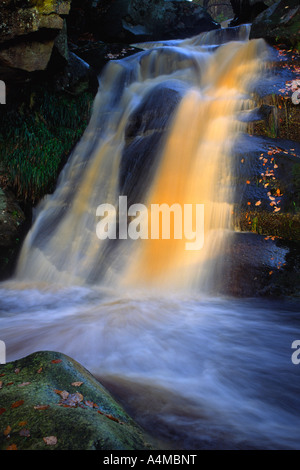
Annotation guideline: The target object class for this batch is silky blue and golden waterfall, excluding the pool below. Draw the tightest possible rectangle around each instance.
[16,26,267,290]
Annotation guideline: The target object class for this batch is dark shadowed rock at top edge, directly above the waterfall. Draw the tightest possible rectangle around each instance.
[68,0,220,43]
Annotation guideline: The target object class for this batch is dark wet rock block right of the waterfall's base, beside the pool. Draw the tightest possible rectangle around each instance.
[224,232,300,298]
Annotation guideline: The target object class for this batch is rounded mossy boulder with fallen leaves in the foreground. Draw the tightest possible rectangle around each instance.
[0,351,150,450]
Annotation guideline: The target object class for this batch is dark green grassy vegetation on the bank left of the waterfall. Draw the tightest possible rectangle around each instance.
[0,87,93,203]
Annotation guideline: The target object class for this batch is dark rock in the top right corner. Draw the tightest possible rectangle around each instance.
[250,0,300,50]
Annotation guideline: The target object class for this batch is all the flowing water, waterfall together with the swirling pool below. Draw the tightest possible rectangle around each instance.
[1,26,299,449]
